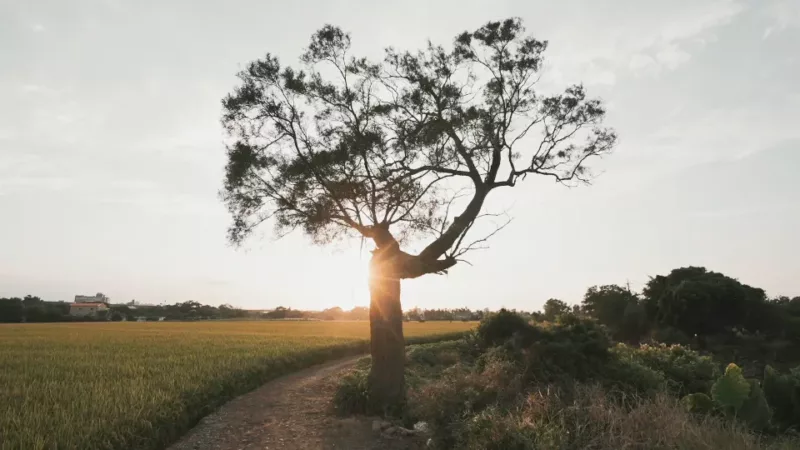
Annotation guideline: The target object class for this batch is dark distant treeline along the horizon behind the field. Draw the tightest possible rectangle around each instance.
[0,267,800,340]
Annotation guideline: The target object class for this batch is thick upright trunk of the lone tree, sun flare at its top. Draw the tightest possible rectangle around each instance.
[369,246,405,414]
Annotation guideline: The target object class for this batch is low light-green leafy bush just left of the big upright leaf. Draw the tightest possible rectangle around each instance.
[613,344,720,397]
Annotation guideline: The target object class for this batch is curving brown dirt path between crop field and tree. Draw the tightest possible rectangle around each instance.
[169,357,424,450]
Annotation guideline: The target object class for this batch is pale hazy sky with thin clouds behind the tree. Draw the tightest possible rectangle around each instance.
[0,0,800,310]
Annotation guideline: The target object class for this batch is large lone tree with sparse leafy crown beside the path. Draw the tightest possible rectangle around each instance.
[221,19,616,406]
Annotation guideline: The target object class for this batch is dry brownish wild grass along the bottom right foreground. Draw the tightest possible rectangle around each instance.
[454,384,798,450]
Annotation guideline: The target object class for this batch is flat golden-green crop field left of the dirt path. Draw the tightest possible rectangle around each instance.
[0,321,474,450]
